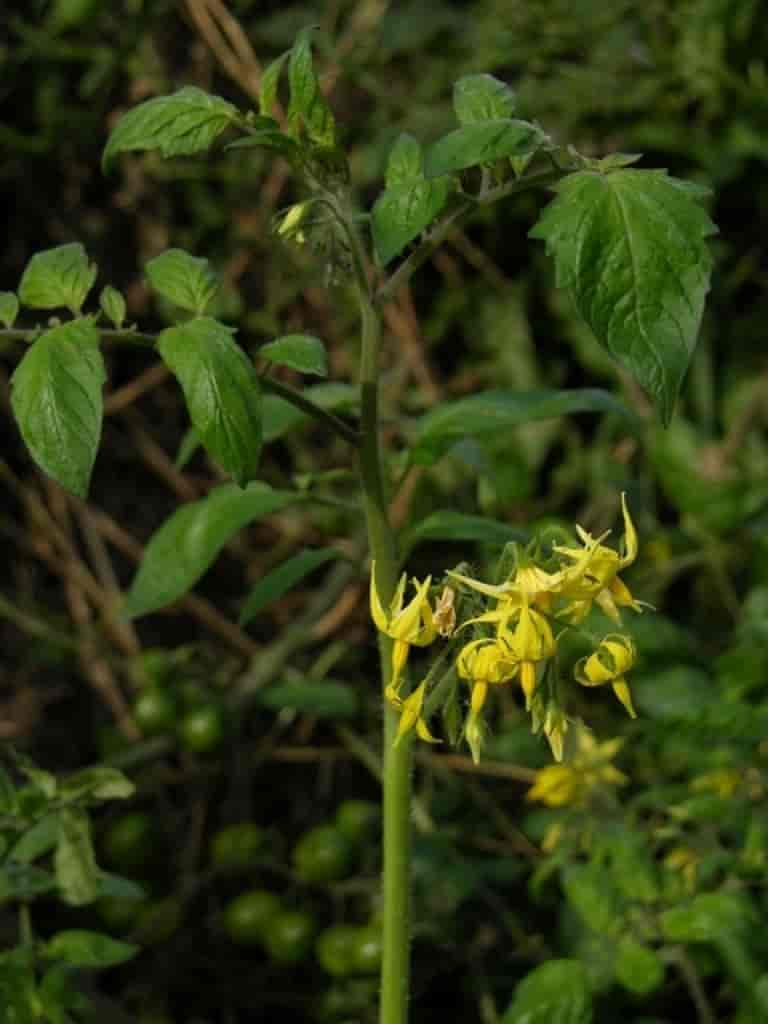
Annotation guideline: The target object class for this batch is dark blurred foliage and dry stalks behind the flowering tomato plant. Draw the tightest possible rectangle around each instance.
[0,0,768,1024]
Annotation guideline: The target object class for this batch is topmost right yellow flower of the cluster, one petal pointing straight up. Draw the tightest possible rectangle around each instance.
[554,494,642,623]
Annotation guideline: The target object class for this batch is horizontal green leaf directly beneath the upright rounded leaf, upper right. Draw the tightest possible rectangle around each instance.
[424,118,544,178]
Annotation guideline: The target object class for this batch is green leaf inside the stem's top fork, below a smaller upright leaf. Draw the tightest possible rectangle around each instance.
[371,178,451,266]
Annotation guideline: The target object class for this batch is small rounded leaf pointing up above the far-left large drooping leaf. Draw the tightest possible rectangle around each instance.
[18,242,98,316]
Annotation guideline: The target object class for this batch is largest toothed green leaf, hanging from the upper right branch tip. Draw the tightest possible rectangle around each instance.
[529,169,716,423]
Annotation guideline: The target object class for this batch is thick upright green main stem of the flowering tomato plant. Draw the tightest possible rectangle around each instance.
[359,280,412,1024]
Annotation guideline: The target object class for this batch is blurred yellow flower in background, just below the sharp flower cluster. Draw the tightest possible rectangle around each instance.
[525,727,628,807]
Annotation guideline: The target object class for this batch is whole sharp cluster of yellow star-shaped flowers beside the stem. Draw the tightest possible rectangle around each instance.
[371,495,642,761]
